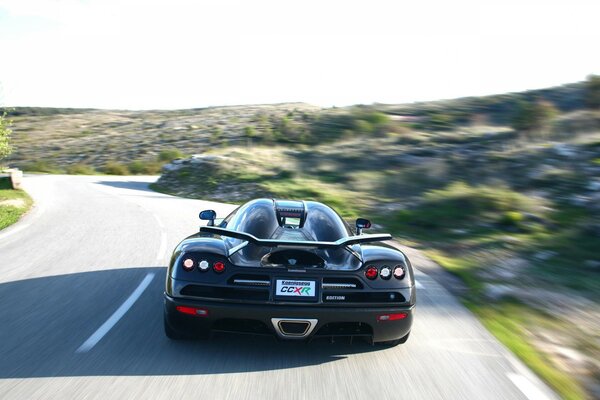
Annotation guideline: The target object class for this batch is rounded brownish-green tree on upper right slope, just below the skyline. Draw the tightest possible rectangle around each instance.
[511,101,558,137]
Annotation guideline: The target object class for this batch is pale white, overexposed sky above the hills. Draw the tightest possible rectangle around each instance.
[0,0,600,109]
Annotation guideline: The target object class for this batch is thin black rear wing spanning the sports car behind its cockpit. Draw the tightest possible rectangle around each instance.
[200,226,392,255]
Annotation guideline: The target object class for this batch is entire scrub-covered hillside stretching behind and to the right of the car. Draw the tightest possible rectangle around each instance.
[3,78,600,399]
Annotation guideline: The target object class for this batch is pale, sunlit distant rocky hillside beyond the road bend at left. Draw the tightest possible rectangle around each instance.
[7,103,319,173]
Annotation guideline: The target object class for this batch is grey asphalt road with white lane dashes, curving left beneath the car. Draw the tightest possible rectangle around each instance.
[0,175,554,400]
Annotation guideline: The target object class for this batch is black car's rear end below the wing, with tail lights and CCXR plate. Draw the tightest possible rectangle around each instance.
[165,246,416,342]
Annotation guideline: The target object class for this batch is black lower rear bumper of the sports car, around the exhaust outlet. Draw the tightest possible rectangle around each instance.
[164,294,414,342]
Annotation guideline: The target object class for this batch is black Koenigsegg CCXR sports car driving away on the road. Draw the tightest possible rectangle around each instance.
[164,199,416,345]
